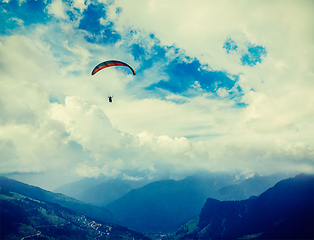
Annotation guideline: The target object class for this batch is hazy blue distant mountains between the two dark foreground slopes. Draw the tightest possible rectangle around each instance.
[54,171,284,233]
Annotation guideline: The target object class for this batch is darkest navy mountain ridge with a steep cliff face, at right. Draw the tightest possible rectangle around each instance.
[176,174,314,239]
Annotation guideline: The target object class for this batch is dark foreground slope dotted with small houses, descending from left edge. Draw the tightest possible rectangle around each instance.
[0,188,148,240]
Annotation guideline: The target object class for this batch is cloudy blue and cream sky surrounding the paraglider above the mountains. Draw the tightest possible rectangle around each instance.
[0,0,314,190]
